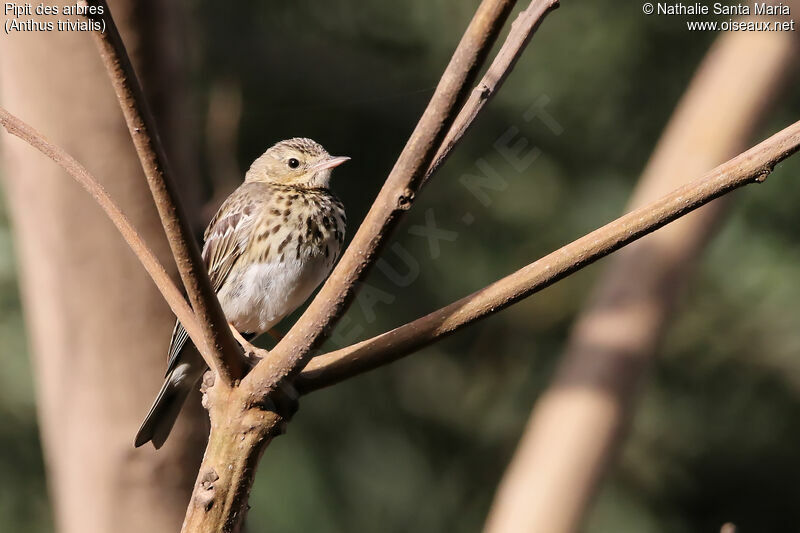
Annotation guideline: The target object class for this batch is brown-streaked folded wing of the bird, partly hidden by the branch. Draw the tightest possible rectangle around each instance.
[167,187,256,374]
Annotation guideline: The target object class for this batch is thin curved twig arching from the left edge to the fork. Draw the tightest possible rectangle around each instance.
[0,107,203,358]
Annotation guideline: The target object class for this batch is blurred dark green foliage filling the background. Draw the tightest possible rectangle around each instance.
[0,0,800,533]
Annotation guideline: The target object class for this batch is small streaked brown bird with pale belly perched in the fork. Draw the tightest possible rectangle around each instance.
[135,138,350,448]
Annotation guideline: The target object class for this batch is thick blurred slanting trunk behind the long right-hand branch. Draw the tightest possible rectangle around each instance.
[485,16,795,533]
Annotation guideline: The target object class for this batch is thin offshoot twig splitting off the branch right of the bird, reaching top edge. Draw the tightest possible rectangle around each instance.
[423,0,559,183]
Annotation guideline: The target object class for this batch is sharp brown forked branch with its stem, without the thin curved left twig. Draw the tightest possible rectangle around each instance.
[21,0,800,531]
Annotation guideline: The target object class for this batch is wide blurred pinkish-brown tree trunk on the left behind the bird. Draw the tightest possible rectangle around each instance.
[0,2,207,533]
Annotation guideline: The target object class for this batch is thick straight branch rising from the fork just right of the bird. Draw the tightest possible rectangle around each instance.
[245,0,515,389]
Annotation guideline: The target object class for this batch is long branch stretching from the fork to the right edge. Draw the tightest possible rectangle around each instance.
[295,118,800,393]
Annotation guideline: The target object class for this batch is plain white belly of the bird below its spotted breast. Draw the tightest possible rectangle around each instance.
[219,254,331,334]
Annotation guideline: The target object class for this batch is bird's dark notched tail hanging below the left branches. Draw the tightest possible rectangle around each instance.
[134,363,204,449]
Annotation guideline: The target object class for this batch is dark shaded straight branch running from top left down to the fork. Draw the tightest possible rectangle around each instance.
[87,0,245,384]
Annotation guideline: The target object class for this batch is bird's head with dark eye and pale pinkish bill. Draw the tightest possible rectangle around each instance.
[245,137,350,189]
